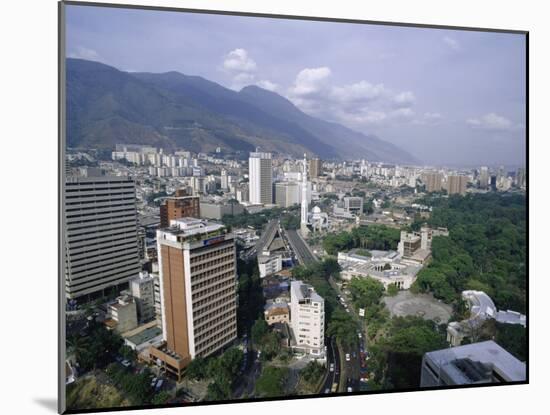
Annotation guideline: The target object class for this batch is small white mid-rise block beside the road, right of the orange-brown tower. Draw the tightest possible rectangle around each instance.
[290,281,325,356]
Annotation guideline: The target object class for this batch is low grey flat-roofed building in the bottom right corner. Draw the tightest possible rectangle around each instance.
[420,340,526,388]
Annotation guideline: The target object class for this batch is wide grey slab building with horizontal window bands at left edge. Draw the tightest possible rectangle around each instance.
[64,171,141,301]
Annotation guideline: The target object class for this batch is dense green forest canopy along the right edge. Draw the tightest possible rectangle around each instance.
[413,193,527,313]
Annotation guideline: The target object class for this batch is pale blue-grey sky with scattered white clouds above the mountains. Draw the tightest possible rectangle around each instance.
[67,6,526,166]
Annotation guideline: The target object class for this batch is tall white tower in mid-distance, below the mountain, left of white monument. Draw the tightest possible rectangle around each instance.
[248,152,273,205]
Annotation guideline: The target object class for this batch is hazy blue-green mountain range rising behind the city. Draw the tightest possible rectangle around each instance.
[67,58,417,163]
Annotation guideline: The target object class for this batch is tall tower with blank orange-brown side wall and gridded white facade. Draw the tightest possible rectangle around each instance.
[149,218,237,380]
